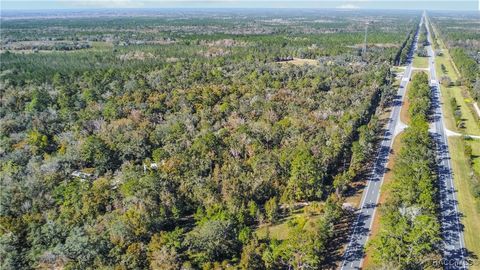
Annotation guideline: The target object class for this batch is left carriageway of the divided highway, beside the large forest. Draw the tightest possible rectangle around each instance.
[341,17,424,269]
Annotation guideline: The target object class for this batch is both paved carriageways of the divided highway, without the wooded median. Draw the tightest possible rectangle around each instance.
[341,13,468,270]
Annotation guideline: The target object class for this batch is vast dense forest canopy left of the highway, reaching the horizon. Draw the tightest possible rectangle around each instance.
[0,11,419,269]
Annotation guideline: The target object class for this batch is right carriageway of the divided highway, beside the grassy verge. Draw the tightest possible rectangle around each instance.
[424,14,467,269]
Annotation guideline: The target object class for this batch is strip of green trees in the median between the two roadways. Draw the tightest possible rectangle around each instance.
[369,72,441,269]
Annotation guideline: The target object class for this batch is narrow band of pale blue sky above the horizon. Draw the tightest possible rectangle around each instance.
[0,0,480,11]
